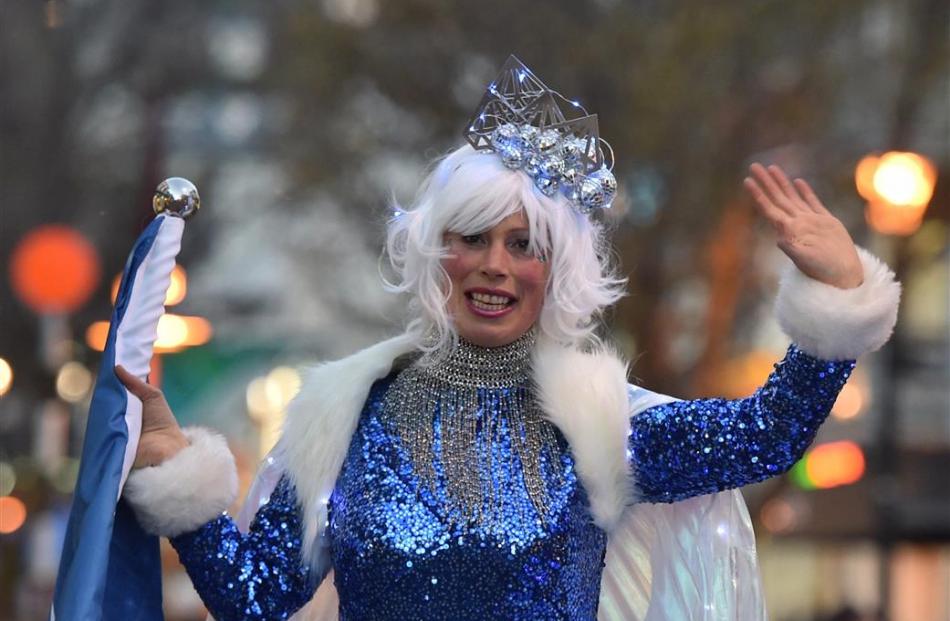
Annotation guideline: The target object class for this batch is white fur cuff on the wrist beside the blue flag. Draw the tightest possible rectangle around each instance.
[122,427,238,537]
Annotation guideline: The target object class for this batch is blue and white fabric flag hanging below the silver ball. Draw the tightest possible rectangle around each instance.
[50,215,185,621]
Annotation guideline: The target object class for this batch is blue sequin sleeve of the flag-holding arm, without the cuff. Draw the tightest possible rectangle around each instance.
[171,477,317,621]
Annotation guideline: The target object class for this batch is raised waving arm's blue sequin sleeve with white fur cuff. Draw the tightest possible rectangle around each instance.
[628,223,900,502]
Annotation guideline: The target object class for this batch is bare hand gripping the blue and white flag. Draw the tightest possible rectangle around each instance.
[115,365,188,468]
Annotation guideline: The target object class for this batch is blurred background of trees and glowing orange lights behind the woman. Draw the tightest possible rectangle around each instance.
[0,0,950,621]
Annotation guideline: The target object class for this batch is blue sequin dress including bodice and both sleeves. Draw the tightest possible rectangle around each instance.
[172,345,854,621]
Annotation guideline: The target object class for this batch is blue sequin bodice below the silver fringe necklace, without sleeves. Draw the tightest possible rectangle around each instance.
[330,382,606,621]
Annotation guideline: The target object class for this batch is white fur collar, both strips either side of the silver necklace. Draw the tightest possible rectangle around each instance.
[281,334,633,569]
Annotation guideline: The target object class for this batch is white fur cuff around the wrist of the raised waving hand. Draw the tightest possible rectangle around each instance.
[775,248,901,360]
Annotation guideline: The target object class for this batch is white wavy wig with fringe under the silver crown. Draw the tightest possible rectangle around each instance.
[386,145,626,359]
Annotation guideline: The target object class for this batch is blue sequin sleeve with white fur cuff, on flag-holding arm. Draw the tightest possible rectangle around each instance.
[123,428,318,621]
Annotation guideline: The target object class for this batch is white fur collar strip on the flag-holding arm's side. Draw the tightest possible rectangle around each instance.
[281,334,414,575]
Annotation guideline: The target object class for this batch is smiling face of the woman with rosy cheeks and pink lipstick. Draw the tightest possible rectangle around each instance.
[442,212,549,347]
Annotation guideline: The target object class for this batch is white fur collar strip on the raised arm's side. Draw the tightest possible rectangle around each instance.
[534,339,634,532]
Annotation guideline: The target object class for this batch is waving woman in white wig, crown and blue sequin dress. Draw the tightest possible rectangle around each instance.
[117,59,899,621]
